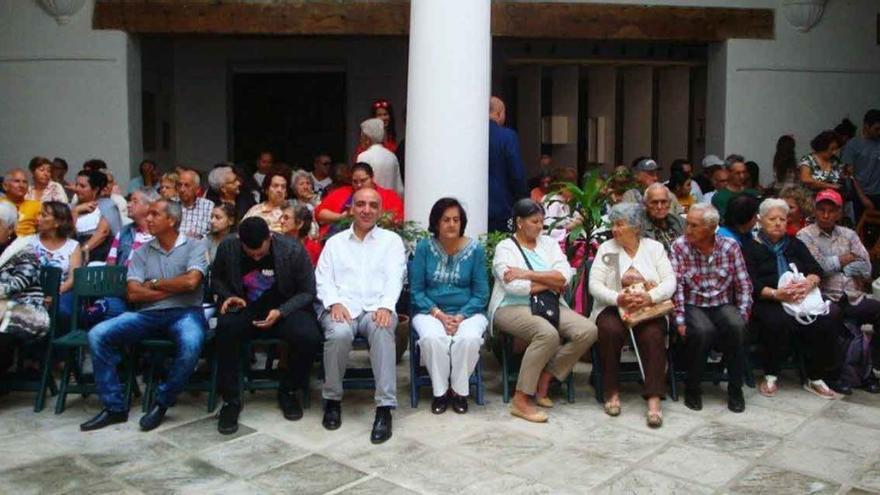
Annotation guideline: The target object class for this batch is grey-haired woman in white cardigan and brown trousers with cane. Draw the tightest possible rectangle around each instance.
[589,203,676,428]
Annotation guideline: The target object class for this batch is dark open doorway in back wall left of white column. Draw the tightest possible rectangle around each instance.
[231,72,345,168]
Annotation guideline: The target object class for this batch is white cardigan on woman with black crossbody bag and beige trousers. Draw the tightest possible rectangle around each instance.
[489,235,574,333]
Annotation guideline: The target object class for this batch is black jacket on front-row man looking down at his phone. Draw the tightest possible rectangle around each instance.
[211,234,317,316]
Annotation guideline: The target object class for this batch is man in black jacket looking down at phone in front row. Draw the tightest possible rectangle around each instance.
[211,217,321,434]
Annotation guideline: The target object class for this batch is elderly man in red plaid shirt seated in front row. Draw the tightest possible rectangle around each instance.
[670,204,752,413]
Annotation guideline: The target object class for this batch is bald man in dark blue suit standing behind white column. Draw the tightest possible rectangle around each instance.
[489,96,528,232]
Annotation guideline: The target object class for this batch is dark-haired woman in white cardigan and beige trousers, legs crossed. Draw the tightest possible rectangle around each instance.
[489,199,596,423]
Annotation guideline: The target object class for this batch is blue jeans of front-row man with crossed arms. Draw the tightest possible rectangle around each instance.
[89,307,208,412]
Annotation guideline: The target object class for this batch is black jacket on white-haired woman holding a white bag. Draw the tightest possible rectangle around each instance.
[743,236,823,301]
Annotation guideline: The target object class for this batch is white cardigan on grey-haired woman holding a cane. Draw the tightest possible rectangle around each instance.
[589,238,676,322]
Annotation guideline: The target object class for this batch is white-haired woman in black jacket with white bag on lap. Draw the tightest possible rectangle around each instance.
[743,198,842,399]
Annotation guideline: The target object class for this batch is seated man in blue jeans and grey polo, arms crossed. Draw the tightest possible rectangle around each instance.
[80,200,208,431]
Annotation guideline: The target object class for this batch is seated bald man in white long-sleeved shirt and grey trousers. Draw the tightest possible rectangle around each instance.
[315,188,406,443]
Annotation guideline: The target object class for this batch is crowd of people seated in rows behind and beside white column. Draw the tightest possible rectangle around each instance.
[0,106,880,452]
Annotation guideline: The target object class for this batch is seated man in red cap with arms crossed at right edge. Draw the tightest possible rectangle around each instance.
[797,189,880,394]
